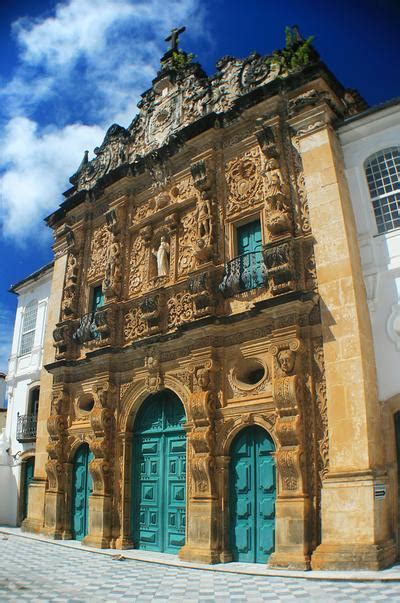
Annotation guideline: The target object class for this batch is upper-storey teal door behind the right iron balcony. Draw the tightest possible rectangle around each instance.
[236,220,263,291]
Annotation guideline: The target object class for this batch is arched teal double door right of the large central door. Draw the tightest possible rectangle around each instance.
[230,426,276,563]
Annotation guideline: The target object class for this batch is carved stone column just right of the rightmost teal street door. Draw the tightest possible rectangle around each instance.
[269,338,311,570]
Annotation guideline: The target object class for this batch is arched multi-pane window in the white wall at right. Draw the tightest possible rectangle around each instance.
[365,147,400,233]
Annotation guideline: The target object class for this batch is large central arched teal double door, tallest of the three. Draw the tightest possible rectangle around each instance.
[132,390,186,553]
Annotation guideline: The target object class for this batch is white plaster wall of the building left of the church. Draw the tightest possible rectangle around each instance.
[0,270,52,525]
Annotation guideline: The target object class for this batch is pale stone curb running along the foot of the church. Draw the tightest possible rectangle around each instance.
[0,526,400,582]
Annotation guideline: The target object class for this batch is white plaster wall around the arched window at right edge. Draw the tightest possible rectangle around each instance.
[339,103,400,401]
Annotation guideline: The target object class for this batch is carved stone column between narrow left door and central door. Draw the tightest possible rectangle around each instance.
[83,383,117,548]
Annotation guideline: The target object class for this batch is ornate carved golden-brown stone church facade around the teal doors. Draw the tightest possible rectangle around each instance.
[24,30,396,569]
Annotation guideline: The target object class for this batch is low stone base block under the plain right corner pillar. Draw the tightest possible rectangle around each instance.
[311,540,396,570]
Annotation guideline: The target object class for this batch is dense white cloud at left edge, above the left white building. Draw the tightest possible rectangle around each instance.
[0,117,104,243]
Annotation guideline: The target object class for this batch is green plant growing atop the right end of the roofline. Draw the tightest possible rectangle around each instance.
[267,27,314,74]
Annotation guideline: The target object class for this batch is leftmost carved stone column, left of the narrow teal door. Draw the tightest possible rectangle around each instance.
[43,389,69,540]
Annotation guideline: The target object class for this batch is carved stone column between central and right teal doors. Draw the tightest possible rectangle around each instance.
[179,363,220,563]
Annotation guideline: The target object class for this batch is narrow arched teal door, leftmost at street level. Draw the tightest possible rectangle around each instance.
[71,444,93,540]
